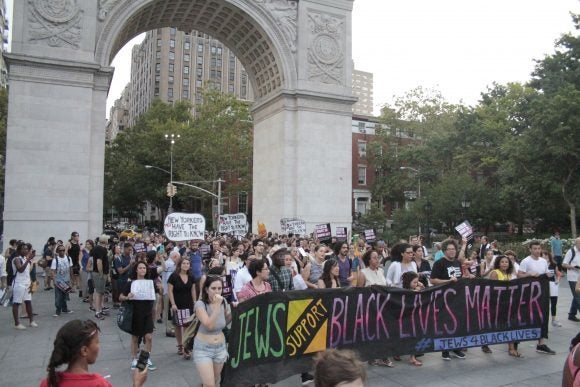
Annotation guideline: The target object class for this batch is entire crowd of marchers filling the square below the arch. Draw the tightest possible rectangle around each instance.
[0,232,580,386]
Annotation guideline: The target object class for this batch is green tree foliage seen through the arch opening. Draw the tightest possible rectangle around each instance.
[105,91,252,223]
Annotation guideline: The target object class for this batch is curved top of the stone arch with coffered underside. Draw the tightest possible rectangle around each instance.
[95,0,298,100]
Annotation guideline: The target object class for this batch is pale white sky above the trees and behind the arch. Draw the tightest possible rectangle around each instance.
[7,0,580,115]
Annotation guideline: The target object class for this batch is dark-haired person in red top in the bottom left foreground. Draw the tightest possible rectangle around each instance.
[40,320,147,387]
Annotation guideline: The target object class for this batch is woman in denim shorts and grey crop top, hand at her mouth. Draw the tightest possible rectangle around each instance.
[193,275,232,387]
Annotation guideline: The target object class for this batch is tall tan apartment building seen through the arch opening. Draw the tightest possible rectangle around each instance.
[128,27,254,126]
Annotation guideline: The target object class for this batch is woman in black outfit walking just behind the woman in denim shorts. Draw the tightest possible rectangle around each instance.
[167,259,197,360]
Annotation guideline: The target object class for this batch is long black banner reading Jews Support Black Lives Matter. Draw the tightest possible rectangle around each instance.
[224,276,550,386]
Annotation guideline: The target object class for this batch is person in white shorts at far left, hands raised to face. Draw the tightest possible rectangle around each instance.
[10,243,38,330]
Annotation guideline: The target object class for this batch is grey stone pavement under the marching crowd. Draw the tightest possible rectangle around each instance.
[0,279,580,387]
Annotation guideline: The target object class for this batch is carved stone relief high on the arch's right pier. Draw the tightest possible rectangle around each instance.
[308,12,345,85]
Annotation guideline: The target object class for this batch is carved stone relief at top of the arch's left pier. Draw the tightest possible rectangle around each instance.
[28,0,83,49]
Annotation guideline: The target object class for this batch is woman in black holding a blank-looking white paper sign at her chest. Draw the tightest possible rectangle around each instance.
[119,261,157,371]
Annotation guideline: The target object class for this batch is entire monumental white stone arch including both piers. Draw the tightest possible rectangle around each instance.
[4,0,355,247]
